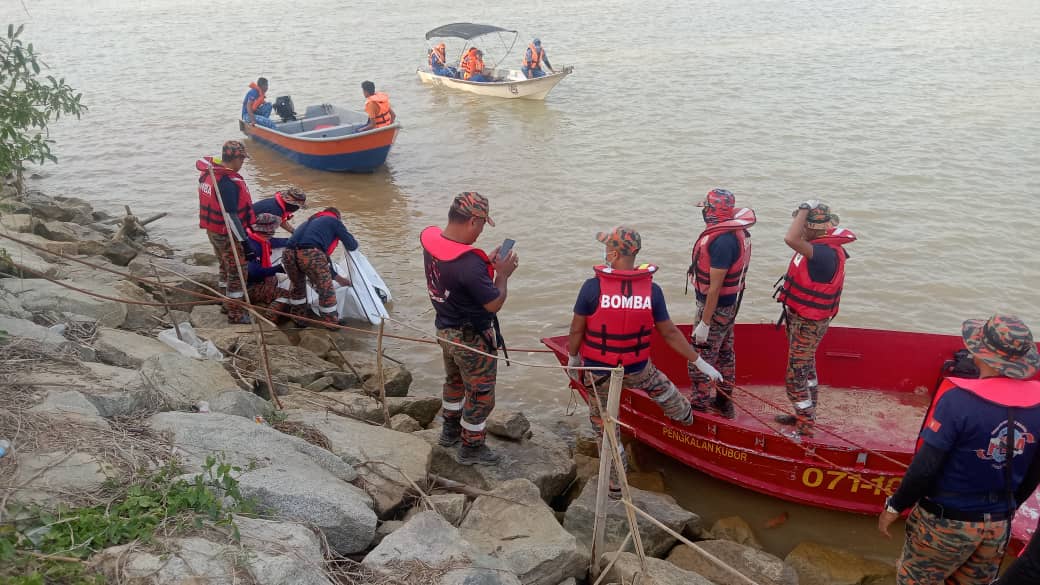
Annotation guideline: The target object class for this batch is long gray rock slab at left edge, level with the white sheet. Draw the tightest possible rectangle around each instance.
[0,278,127,327]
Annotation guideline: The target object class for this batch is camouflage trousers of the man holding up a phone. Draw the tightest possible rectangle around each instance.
[437,327,498,447]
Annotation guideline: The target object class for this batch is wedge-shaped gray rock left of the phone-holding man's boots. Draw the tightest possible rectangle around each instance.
[286,410,432,515]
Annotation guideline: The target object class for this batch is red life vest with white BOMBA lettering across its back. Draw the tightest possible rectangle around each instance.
[581,264,657,365]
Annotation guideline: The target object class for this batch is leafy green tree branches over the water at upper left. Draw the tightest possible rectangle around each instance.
[0,25,86,195]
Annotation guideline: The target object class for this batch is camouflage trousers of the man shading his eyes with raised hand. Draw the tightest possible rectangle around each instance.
[784,310,831,436]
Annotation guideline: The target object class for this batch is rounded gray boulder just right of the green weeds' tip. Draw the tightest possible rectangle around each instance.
[238,463,379,555]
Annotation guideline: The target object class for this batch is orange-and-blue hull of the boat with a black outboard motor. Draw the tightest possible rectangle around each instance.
[238,120,399,173]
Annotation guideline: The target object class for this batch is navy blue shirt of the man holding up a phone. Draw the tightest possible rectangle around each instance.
[422,250,500,331]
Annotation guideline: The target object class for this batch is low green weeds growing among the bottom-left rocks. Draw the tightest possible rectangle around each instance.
[0,457,255,585]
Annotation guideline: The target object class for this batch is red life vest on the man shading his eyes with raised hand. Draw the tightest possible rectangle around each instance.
[777,228,856,321]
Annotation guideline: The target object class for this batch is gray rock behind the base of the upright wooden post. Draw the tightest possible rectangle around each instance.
[564,470,700,557]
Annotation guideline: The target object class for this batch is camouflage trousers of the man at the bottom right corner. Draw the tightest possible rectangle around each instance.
[895,506,1011,585]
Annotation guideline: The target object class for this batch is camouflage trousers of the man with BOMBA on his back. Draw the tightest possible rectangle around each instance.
[586,361,694,490]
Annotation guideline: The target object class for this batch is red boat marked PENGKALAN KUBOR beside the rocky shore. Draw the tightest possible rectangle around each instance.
[542,324,1040,550]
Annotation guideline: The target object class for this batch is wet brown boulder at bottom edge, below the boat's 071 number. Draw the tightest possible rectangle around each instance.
[784,541,895,585]
